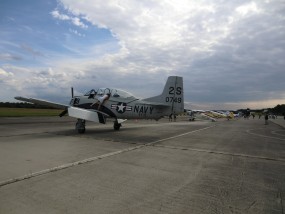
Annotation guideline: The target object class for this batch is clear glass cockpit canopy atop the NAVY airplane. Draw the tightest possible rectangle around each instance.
[84,88,136,99]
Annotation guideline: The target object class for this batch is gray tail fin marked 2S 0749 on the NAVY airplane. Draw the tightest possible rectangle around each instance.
[145,76,184,114]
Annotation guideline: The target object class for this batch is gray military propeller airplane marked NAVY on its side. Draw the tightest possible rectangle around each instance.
[15,76,184,133]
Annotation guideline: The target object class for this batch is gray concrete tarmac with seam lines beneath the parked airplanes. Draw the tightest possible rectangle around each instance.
[0,117,285,214]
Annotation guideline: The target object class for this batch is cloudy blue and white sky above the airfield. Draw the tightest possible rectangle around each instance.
[0,0,285,110]
